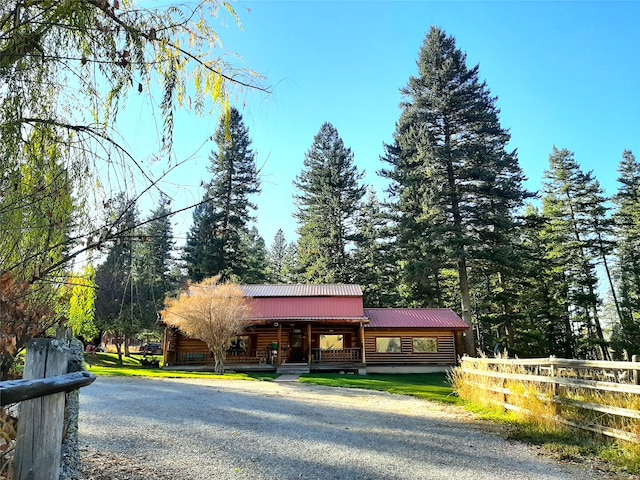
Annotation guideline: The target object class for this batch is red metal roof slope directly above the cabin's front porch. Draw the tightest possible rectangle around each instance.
[251,297,366,320]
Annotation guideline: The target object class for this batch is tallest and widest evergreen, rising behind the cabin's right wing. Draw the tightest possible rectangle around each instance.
[382,27,527,354]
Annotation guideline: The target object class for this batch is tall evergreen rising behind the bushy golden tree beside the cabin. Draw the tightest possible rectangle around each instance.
[184,108,260,281]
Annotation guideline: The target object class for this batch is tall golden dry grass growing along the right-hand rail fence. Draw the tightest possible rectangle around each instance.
[451,358,640,473]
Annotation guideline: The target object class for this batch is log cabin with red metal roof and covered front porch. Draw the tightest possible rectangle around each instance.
[164,285,467,373]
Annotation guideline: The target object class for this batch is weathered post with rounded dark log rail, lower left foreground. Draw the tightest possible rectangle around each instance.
[0,339,96,480]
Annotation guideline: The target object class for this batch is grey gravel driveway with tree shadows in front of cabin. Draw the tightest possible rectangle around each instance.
[80,377,606,480]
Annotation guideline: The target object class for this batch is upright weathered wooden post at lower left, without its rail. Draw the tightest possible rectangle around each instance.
[13,338,68,480]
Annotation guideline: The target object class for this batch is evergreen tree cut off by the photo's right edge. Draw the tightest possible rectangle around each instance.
[613,150,640,355]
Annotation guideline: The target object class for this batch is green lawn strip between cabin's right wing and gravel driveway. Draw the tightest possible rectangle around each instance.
[299,373,461,405]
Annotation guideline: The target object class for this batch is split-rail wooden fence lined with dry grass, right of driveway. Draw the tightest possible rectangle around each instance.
[456,355,640,443]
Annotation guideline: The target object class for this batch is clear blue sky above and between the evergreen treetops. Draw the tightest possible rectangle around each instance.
[130,1,640,251]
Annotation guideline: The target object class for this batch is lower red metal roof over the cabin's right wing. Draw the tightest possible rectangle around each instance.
[364,308,468,330]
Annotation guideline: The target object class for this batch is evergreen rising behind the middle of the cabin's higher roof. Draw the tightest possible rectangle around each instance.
[294,123,365,283]
